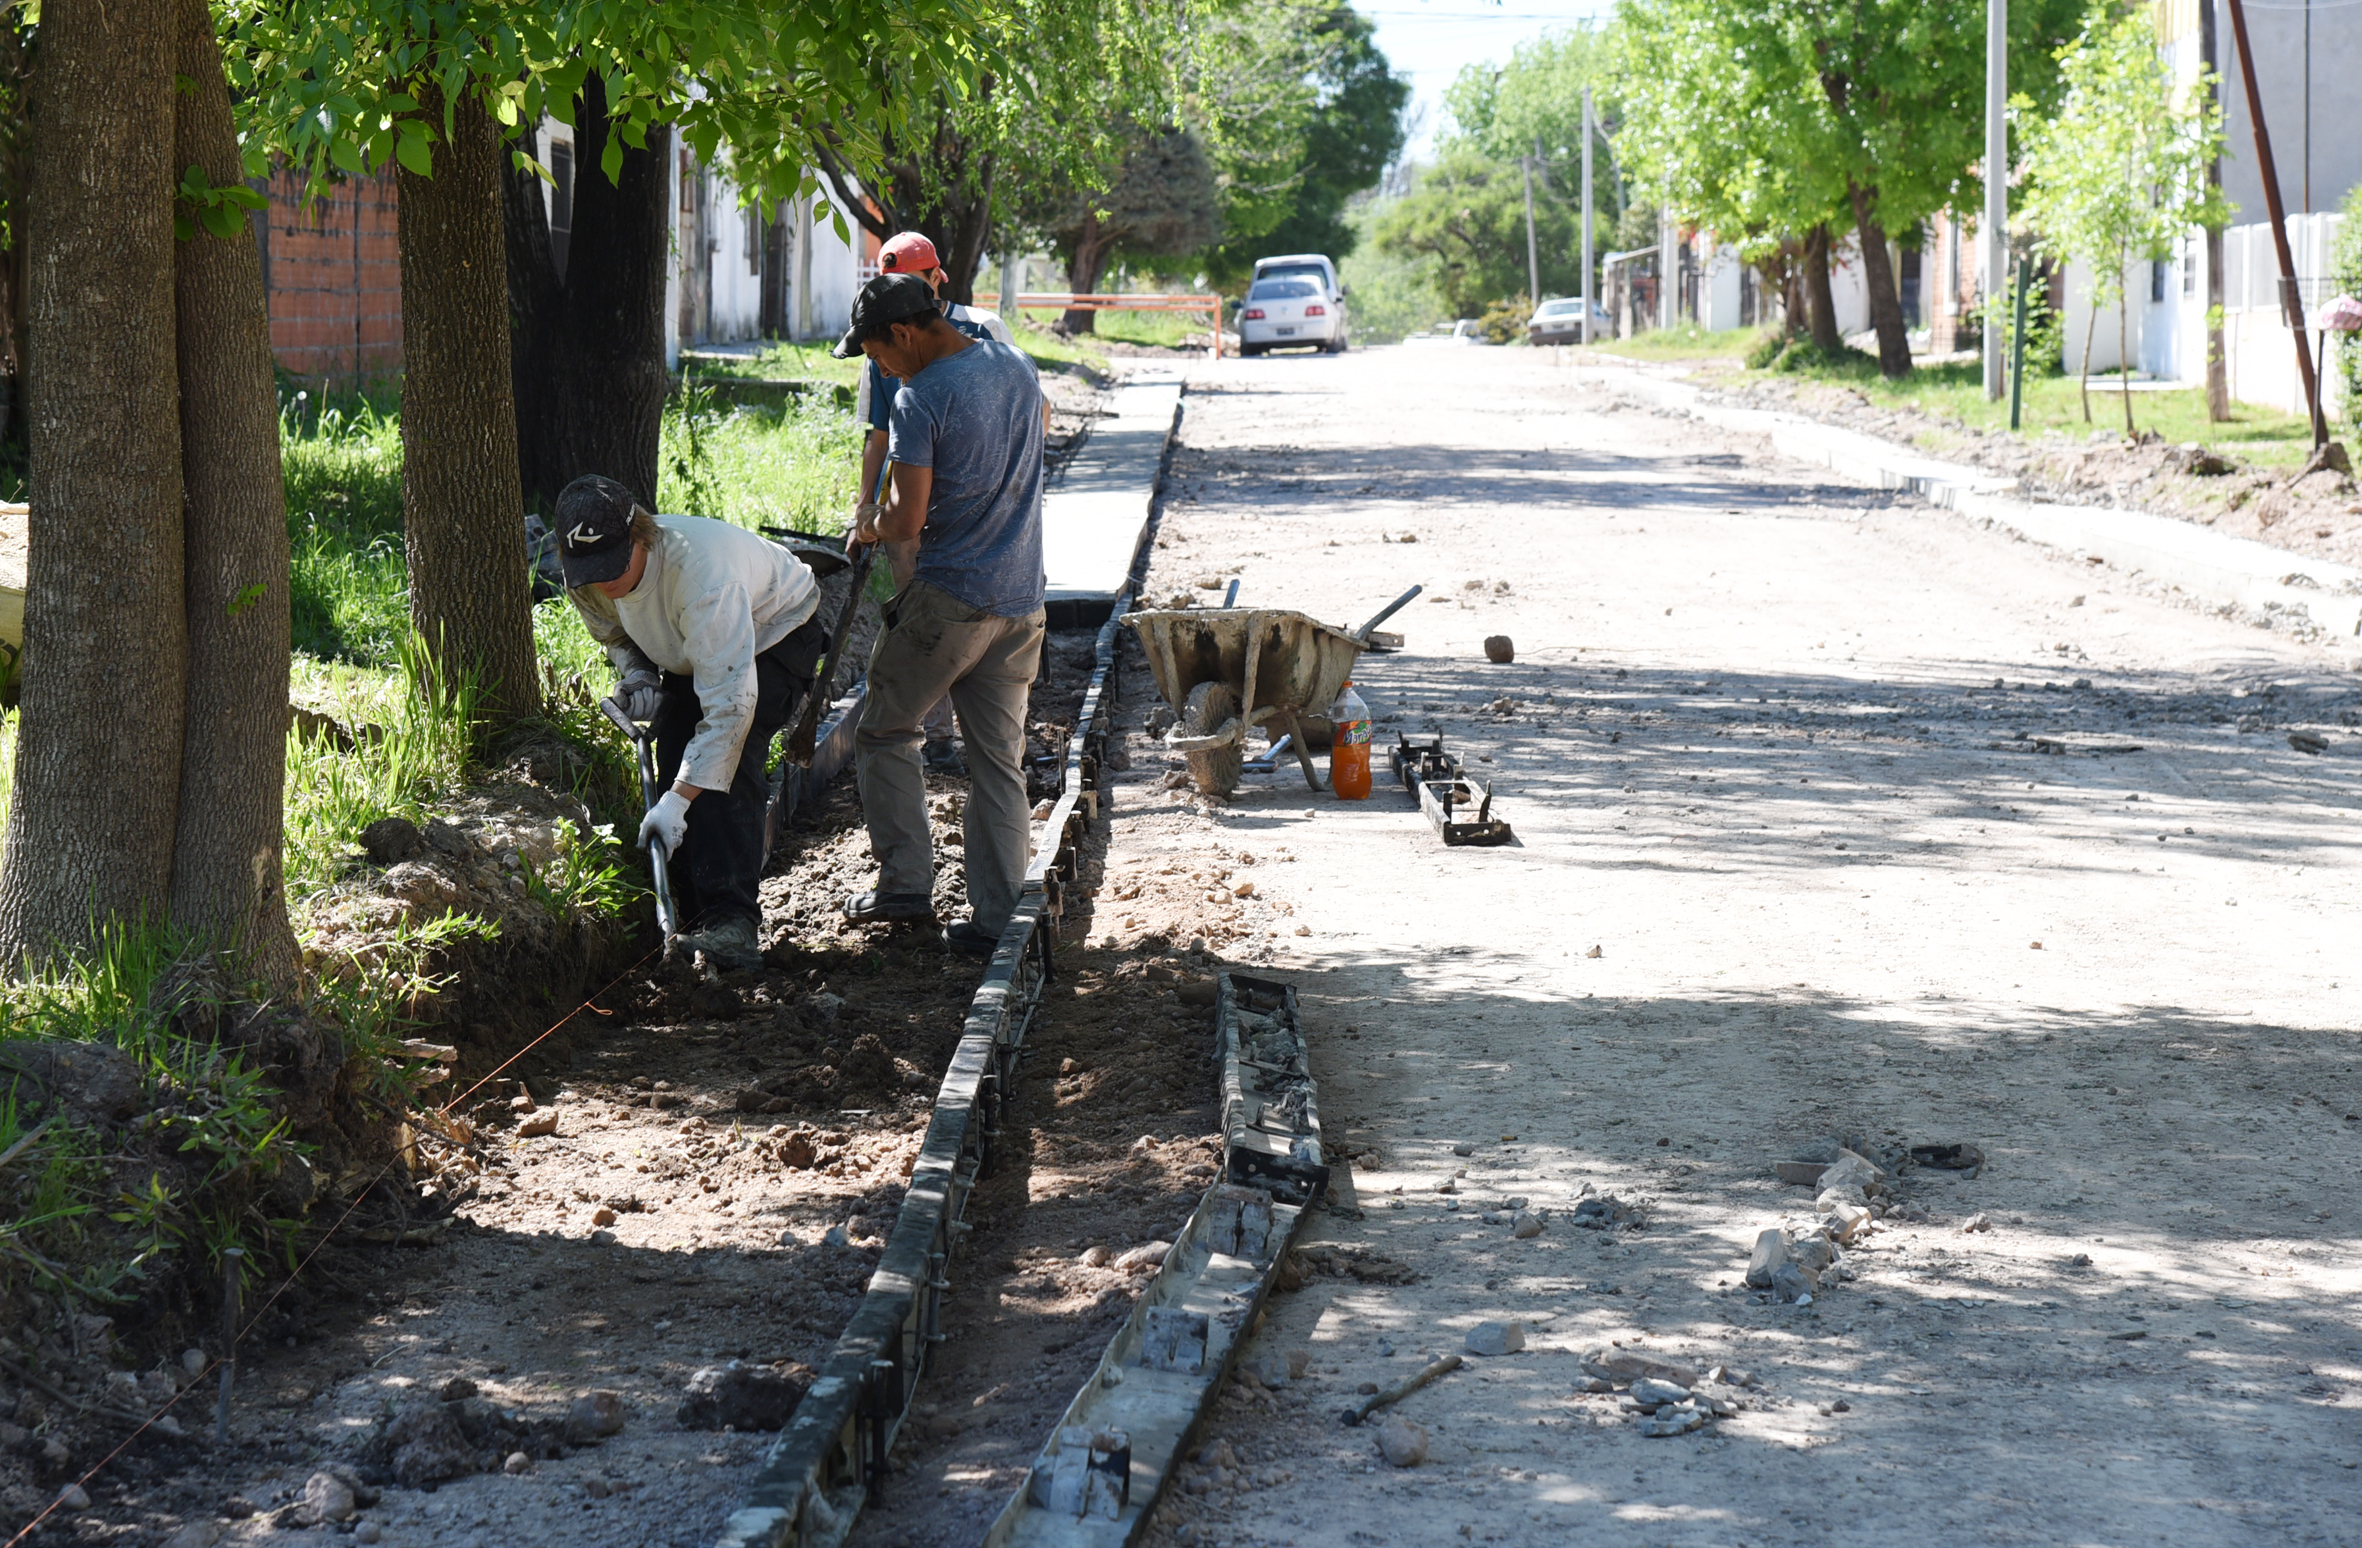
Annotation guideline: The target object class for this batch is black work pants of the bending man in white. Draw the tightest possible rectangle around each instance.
[654,614,829,931]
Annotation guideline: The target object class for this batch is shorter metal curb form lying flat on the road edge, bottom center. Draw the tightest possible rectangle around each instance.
[985,974,1330,1548]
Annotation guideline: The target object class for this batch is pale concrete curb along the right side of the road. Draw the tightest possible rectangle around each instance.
[1585,366,2362,638]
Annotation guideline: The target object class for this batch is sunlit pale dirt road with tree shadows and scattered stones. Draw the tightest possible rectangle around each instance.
[1094,350,2362,1548]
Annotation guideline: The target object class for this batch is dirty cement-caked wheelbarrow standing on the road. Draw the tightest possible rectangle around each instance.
[1124,607,1368,796]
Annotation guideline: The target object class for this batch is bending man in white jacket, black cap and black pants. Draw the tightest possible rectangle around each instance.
[557,475,827,971]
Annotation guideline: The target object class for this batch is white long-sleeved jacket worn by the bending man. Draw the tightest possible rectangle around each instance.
[567,515,820,789]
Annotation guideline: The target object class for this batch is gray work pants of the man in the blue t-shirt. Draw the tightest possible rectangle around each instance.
[855,581,1044,931]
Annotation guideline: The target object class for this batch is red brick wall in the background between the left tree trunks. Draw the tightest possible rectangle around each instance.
[255,170,402,383]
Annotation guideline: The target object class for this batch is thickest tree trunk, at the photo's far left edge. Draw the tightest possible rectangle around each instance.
[0,0,189,967]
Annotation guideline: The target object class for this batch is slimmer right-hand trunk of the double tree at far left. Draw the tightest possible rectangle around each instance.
[172,0,295,988]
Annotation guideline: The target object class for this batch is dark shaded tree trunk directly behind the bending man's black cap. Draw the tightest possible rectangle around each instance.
[503,76,673,510]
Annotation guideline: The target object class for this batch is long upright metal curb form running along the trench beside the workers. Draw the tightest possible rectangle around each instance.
[716,590,1146,1548]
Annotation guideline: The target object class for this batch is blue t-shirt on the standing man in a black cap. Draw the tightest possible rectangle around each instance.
[886,340,1046,617]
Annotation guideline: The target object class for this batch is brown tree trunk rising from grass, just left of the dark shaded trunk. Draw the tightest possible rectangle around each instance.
[402,90,541,723]
